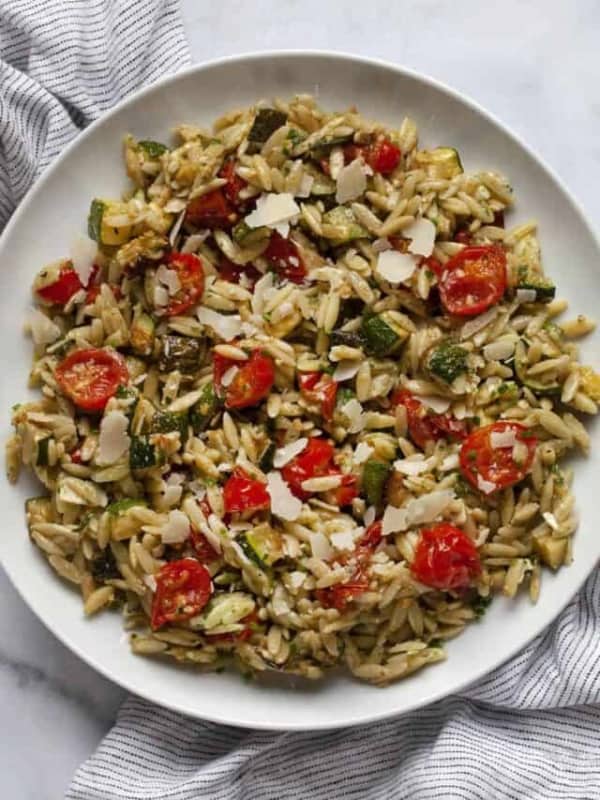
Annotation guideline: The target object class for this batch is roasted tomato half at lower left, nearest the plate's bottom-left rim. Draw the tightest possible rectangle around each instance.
[151,558,212,630]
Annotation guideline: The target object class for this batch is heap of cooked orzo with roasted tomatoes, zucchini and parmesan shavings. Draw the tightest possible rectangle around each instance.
[7,96,600,684]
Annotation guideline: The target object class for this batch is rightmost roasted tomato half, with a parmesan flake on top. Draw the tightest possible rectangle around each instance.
[460,421,537,494]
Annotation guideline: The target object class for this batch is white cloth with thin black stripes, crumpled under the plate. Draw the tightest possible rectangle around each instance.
[0,0,600,800]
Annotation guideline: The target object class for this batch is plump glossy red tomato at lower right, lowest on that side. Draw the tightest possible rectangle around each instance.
[410,522,481,591]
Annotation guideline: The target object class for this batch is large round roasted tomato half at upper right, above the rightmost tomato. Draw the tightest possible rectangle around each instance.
[438,245,506,316]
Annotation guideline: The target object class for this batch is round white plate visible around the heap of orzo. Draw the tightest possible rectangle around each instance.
[0,52,600,730]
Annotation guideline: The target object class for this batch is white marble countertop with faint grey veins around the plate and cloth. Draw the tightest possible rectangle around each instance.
[0,0,600,800]
